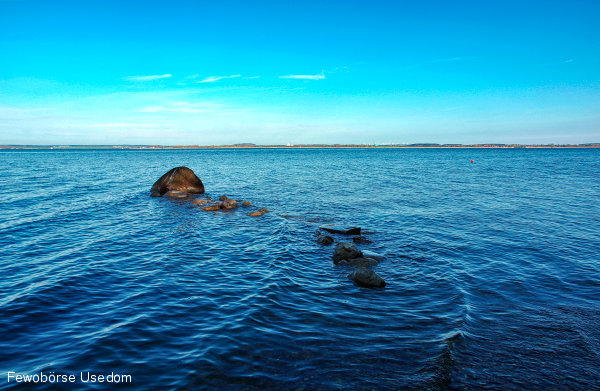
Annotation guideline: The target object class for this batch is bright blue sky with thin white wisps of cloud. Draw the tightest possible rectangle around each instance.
[0,0,600,145]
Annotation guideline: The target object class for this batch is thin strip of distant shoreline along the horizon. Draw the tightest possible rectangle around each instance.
[0,143,600,150]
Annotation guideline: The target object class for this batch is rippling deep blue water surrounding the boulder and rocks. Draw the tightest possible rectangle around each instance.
[0,149,600,390]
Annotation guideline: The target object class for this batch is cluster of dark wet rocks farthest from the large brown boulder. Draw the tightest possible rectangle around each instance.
[317,227,386,288]
